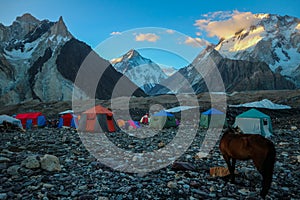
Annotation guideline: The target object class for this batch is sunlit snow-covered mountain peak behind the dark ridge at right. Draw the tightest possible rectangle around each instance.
[215,14,300,86]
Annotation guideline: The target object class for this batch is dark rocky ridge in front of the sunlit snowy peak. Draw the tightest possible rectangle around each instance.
[151,47,296,94]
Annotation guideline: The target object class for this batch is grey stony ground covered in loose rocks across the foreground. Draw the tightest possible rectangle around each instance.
[0,107,300,200]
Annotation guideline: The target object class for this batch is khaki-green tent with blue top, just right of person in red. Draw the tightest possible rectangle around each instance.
[150,110,177,129]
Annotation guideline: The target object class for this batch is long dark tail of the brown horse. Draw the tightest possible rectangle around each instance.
[260,142,276,198]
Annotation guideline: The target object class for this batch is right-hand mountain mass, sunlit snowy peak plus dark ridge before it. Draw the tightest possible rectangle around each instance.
[150,14,300,95]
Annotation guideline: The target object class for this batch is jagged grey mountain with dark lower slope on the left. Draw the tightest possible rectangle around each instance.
[0,14,145,105]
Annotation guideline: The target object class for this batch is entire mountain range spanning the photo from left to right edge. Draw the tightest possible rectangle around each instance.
[0,14,300,105]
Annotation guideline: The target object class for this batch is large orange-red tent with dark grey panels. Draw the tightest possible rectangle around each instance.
[79,105,120,132]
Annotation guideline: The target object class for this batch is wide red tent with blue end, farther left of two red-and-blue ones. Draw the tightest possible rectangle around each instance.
[16,112,46,129]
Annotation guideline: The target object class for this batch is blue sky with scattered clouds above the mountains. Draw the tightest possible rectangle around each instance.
[0,0,300,68]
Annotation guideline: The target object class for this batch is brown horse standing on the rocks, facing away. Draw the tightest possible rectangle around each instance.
[219,128,276,198]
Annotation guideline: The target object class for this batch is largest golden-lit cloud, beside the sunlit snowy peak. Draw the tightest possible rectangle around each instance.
[194,11,259,39]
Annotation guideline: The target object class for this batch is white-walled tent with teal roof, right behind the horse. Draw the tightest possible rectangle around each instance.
[234,108,272,137]
